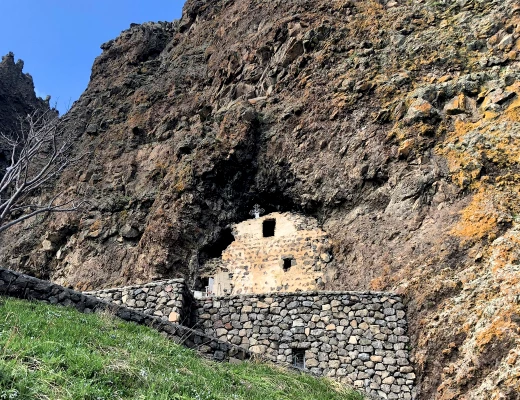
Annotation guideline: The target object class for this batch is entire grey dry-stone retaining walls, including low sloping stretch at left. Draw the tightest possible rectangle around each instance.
[0,269,416,399]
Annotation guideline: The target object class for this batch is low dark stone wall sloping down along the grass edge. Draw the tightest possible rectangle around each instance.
[0,268,251,362]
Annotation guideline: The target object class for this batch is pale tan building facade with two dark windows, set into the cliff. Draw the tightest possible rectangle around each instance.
[203,213,335,296]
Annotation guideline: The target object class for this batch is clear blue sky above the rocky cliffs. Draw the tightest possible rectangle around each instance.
[0,0,184,113]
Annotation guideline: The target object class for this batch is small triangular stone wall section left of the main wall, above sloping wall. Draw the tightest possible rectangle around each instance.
[85,279,194,327]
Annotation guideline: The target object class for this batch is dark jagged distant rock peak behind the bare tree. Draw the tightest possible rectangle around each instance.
[0,53,50,170]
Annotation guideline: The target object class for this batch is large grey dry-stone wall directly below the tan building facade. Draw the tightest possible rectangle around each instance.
[198,292,415,399]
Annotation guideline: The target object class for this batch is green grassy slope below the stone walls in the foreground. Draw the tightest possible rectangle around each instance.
[0,297,363,400]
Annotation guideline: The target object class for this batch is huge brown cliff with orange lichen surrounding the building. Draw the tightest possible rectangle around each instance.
[0,0,520,400]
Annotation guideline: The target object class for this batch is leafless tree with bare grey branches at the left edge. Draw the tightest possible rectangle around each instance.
[0,110,84,232]
